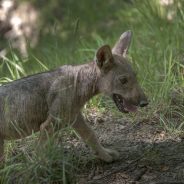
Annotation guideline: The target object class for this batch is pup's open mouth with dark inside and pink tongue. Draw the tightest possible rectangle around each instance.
[112,94,137,113]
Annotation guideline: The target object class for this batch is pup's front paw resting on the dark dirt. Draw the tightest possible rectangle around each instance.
[99,148,119,163]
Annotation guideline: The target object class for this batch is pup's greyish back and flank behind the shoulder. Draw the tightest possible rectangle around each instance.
[0,69,62,139]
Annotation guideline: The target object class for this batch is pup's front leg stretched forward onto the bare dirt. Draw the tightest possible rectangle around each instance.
[73,114,119,162]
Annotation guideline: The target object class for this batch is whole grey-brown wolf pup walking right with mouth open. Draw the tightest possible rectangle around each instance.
[0,31,148,162]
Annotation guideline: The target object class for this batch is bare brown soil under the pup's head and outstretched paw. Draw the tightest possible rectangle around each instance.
[67,110,184,184]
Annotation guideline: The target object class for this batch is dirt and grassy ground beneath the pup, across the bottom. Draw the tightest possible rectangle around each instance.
[0,100,184,184]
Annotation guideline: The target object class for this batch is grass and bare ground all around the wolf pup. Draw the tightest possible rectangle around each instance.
[0,0,184,184]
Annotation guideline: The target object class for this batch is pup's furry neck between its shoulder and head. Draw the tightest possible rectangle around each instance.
[76,62,100,103]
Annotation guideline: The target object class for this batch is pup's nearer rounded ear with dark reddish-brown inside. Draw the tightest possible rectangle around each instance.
[95,45,113,72]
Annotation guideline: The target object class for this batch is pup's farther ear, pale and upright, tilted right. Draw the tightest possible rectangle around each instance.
[112,31,132,57]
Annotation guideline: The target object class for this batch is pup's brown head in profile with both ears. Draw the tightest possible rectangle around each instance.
[95,31,148,113]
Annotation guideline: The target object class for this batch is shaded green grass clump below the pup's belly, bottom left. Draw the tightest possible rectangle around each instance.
[0,130,79,184]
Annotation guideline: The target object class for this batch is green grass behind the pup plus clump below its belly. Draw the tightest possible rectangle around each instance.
[0,0,184,183]
